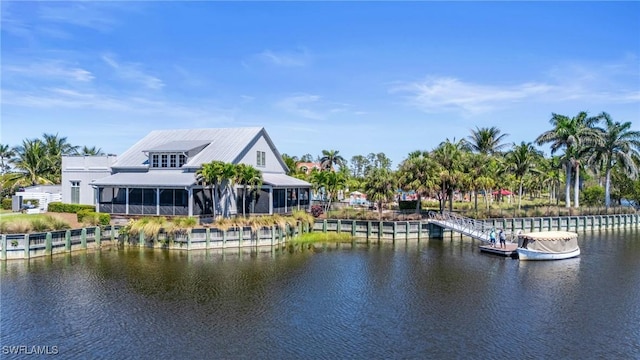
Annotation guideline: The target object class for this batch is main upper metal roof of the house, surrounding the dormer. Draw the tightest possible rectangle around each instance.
[112,127,264,169]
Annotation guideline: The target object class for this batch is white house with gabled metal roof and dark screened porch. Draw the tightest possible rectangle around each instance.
[63,128,311,217]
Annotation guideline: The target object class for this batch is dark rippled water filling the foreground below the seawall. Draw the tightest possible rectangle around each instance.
[0,230,640,359]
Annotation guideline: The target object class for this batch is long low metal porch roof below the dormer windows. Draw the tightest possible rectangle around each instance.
[91,170,196,187]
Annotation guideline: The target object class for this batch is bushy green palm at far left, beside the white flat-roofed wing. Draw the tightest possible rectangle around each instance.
[11,139,55,186]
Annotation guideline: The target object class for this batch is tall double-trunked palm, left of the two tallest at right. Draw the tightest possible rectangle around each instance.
[536,111,601,208]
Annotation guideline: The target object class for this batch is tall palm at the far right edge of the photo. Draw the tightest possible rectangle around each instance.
[592,112,640,207]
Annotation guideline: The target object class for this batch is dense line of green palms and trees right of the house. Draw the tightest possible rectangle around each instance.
[283,111,640,215]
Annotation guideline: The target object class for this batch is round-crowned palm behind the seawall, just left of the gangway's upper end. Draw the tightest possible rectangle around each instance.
[397,153,438,213]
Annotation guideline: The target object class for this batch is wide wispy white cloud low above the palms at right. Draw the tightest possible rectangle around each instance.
[389,61,640,115]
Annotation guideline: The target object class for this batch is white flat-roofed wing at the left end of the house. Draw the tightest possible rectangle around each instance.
[61,155,116,205]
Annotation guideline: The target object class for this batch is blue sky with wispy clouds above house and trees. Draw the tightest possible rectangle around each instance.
[1,1,640,168]
